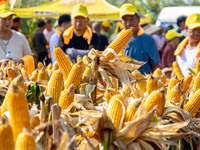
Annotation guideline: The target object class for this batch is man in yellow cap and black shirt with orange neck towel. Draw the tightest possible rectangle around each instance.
[58,4,98,60]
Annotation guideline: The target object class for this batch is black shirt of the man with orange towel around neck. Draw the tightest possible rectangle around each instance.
[58,33,98,52]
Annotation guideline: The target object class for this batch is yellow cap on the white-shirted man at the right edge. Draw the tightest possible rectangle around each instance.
[185,13,200,29]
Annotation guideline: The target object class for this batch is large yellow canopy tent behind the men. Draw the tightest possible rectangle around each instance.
[13,0,119,21]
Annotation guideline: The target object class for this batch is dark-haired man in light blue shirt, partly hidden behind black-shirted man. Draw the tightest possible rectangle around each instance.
[49,15,71,64]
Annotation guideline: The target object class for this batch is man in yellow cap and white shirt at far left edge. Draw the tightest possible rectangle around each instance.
[0,4,32,64]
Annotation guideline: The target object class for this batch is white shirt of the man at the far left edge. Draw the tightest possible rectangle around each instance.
[0,30,32,60]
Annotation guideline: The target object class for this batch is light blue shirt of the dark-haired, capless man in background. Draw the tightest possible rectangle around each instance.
[49,32,59,64]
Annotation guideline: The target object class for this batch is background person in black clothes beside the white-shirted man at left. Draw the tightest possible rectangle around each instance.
[33,20,48,64]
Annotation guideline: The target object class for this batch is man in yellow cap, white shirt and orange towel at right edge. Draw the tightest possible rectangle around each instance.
[174,13,200,76]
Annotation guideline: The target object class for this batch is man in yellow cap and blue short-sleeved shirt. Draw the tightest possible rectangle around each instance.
[120,4,160,74]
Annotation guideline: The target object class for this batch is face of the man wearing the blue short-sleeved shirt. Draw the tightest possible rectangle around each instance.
[121,15,140,34]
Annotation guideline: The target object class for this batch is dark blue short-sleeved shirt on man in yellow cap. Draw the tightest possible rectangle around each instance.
[124,33,160,74]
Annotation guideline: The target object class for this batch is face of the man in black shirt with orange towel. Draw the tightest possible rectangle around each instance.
[71,16,89,31]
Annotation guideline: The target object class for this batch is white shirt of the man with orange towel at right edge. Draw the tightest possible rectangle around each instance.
[176,48,197,77]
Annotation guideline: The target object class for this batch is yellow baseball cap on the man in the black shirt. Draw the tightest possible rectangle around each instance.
[71,4,88,18]
